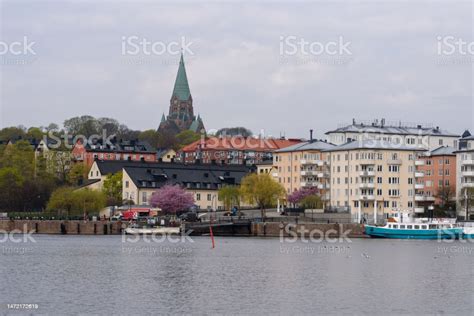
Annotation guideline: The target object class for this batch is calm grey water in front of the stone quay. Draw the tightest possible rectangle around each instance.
[0,235,474,315]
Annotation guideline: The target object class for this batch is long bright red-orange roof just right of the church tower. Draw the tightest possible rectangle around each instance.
[182,136,301,152]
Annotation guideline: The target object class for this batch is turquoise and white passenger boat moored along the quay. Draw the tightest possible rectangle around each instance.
[365,222,463,239]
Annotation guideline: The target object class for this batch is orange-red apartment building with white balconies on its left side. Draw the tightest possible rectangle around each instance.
[415,146,456,210]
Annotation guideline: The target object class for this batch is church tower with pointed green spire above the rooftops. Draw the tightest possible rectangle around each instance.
[158,53,204,134]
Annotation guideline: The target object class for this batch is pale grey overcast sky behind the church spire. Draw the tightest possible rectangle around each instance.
[0,0,474,137]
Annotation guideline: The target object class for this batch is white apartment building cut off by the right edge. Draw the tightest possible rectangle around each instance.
[455,136,474,220]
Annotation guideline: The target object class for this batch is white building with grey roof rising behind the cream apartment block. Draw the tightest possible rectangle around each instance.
[326,119,460,150]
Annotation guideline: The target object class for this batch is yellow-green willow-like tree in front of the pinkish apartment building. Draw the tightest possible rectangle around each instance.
[240,173,285,219]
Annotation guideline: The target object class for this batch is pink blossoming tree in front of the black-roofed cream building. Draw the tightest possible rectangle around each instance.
[150,185,194,214]
